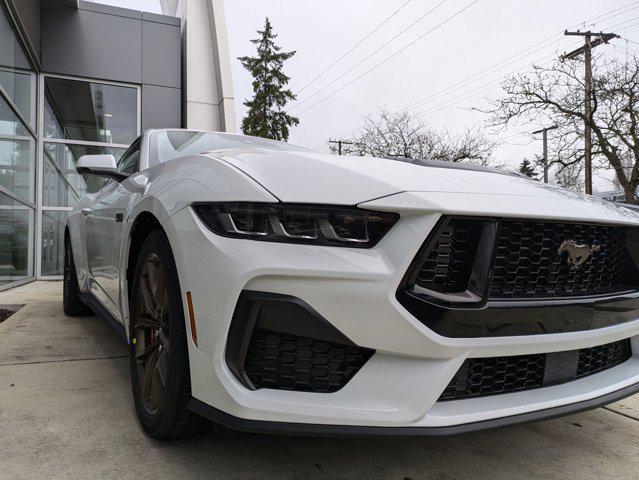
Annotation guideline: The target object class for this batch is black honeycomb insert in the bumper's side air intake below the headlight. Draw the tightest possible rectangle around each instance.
[244,329,374,393]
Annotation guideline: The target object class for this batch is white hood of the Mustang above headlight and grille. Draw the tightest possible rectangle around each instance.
[208,149,616,205]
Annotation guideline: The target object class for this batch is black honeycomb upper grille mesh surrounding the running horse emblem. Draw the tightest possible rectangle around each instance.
[490,220,632,299]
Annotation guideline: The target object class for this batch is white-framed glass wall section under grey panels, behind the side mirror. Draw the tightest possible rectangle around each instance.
[39,75,140,277]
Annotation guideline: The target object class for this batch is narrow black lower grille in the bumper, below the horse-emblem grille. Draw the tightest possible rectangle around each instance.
[439,340,632,401]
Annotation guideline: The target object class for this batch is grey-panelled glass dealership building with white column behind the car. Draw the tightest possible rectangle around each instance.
[0,0,236,290]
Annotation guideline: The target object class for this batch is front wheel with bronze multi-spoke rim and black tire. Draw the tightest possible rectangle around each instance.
[129,230,204,440]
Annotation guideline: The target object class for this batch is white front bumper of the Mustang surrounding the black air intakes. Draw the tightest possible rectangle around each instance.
[165,199,639,435]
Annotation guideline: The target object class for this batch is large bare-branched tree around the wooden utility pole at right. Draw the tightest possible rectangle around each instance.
[488,56,639,203]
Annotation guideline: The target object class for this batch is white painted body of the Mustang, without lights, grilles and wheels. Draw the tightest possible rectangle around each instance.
[69,131,639,434]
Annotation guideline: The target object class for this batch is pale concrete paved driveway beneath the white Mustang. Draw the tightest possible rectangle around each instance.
[0,282,639,480]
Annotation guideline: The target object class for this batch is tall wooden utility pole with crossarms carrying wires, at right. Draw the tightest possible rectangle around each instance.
[561,30,619,195]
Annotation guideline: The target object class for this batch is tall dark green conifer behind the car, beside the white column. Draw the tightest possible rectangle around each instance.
[238,17,299,142]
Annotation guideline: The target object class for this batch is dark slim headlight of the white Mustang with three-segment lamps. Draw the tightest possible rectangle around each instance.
[193,203,399,248]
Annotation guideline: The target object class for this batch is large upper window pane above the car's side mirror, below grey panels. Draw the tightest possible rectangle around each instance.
[44,77,138,145]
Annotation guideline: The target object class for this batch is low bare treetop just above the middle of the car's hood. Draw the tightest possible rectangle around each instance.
[330,110,495,165]
